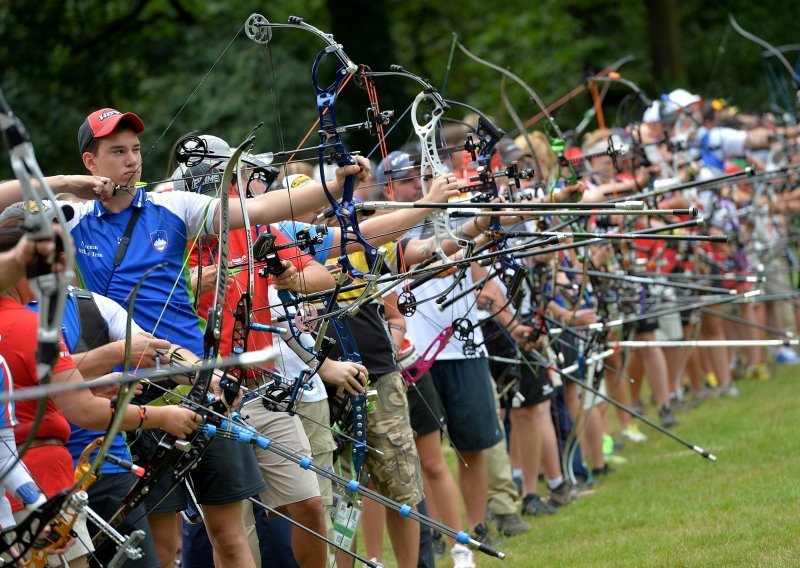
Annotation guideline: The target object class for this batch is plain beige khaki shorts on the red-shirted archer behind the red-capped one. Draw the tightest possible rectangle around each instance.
[247,403,320,508]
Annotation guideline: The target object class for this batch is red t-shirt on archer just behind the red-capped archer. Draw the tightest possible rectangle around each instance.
[189,193,312,356]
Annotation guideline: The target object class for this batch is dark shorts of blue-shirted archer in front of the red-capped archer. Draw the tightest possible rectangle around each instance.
[86,473,161,568]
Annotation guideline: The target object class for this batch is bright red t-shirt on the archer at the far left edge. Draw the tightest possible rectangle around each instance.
[0,296,75,511]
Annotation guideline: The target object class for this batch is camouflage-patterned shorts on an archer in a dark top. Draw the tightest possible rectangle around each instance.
[364,373,423,505]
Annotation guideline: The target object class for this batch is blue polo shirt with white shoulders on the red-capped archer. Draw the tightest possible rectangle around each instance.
[68,187,217,356]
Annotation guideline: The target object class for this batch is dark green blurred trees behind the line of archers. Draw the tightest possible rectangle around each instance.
[0,0,800,180]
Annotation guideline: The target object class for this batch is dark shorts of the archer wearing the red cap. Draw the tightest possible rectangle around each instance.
[144,430,267,513]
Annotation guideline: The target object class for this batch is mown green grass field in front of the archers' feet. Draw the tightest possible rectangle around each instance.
[366,367,800,568]
